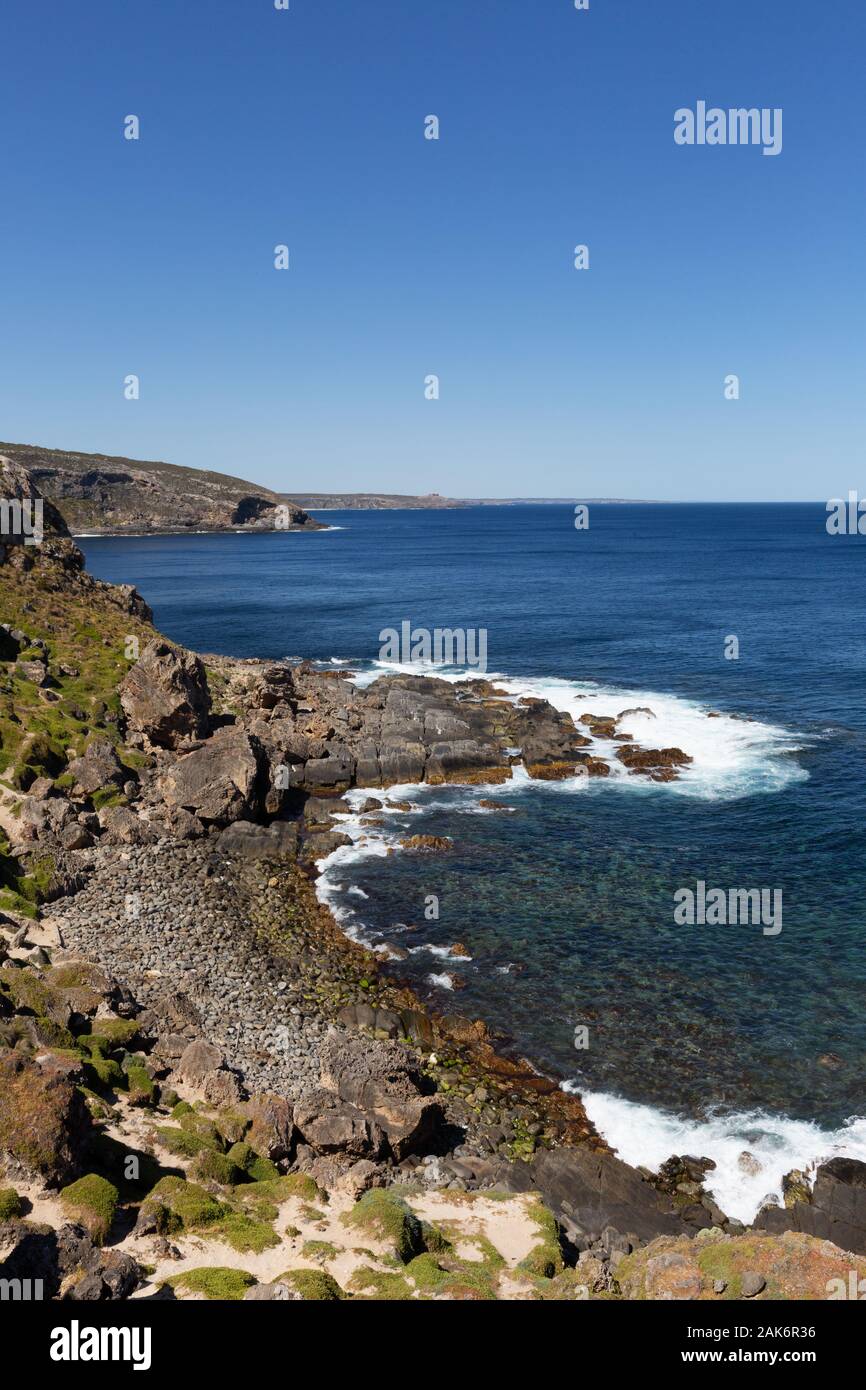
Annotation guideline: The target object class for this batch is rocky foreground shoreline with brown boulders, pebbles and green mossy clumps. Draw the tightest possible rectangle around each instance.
[0,464,866,1298]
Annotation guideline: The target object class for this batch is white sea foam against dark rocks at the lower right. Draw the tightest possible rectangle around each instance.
[563,1081,866,1223]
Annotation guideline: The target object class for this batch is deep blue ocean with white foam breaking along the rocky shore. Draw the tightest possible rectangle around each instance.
[79,503,866,1219]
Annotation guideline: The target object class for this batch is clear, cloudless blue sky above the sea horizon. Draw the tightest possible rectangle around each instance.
[0,0,866,500]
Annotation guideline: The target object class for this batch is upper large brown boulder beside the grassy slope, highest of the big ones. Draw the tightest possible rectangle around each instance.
[120,638,210,748]
